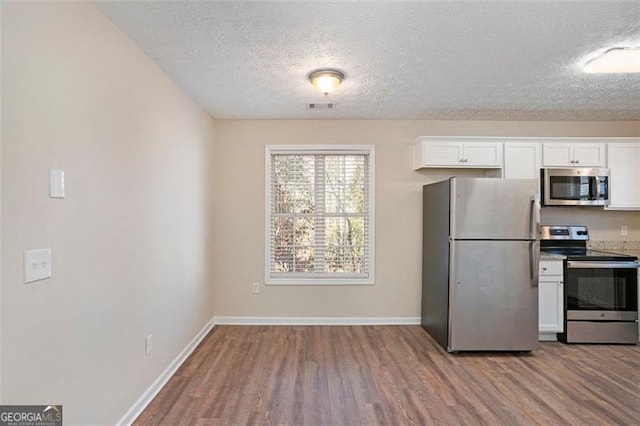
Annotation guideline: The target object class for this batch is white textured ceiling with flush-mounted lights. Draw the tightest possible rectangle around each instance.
[98,0,640,120]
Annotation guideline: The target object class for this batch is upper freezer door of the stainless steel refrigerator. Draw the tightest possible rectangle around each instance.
[450,178,540,240]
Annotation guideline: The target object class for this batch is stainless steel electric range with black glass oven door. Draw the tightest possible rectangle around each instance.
[540,226,640,344]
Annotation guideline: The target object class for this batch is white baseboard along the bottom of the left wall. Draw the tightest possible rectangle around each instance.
[116,318,215,425]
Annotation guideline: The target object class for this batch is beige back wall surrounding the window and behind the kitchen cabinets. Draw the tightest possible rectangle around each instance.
[214,120,640,318]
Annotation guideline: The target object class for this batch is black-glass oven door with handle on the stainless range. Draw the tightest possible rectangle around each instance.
[565,260,638,321]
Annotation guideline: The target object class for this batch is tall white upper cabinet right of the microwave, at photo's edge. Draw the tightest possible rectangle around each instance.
[607,142,640,210]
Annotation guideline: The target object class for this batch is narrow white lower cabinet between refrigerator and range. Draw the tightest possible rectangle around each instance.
[538,260,564,340]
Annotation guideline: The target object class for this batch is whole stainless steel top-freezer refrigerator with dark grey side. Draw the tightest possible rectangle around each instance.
[421,178,540,352]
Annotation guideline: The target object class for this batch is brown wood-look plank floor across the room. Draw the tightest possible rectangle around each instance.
[135,326,640,425]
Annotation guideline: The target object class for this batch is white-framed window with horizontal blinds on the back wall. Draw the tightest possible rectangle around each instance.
[266,145,374,284]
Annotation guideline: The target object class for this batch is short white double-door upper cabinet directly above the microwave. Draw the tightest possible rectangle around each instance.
[542,142,606,167]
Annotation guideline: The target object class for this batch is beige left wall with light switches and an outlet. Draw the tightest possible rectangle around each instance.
[1,2,214,424]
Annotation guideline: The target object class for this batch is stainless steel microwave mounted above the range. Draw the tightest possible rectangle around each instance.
[541,167,609,206]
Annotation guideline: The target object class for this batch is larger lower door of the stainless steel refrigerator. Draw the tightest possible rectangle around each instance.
[448,241,539,351]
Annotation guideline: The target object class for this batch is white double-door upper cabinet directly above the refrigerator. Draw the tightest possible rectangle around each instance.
[413,137,503,170]
